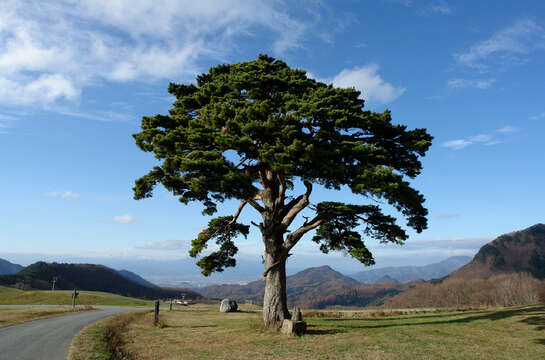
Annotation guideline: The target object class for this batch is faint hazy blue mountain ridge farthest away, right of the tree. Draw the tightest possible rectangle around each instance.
[350,256,471,284]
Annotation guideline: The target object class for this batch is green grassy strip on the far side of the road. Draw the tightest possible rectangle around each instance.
[0,286,152,306]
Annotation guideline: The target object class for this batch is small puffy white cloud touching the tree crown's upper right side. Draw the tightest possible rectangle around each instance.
[327,64,407,104]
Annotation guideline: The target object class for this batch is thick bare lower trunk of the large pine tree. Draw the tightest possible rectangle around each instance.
[263,254,290,328]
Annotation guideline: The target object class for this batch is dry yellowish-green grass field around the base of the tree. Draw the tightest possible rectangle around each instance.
[68,306,545,360]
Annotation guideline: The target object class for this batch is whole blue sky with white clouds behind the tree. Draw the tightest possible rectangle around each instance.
[0,0,545,280]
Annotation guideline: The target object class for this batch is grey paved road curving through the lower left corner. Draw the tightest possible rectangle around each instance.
[0,306,145,360]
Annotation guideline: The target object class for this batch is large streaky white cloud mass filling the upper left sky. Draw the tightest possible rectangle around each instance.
[0,0,312,106]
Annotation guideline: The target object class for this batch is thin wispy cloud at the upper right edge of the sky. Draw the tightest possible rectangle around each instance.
[455,20,545,69]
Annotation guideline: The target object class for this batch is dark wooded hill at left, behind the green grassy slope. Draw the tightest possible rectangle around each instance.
[0,261,201,299]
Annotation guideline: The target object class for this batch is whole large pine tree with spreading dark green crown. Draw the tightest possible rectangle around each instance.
[134,55,432,326]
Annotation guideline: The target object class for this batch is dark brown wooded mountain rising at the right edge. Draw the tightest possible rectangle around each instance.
[451,224,545,279]
